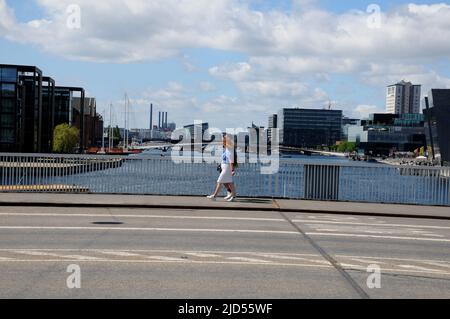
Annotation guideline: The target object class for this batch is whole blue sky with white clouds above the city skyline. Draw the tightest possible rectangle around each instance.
[0,0,450,128]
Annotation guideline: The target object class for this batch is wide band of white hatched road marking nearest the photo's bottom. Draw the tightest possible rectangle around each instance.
[0,249,450,276]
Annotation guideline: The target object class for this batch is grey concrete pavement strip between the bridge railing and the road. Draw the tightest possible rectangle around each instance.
[0,193,450,220]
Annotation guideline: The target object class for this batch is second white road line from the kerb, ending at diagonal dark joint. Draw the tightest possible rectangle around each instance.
[0,226,300,236]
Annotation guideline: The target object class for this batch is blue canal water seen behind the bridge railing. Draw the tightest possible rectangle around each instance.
[46,152,450,205]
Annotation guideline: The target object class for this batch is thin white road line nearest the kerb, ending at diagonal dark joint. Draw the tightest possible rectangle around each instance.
[0,213,286,222]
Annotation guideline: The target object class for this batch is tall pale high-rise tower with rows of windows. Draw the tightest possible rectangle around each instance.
[386,81,421,114]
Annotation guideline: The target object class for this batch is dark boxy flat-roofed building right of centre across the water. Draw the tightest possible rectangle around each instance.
[277,108,342,148]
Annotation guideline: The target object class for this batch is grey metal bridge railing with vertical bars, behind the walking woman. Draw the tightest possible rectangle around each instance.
[0,154,450,206]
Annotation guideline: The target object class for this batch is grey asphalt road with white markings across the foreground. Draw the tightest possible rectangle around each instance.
[0,207,450,299]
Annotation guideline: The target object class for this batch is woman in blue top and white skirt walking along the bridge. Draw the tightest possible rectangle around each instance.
[208,135,236,202]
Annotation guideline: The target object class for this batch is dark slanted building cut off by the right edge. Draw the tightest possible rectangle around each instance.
[423,89,450,166]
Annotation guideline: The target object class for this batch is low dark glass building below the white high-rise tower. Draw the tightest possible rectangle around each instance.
[348,114,426,156]
